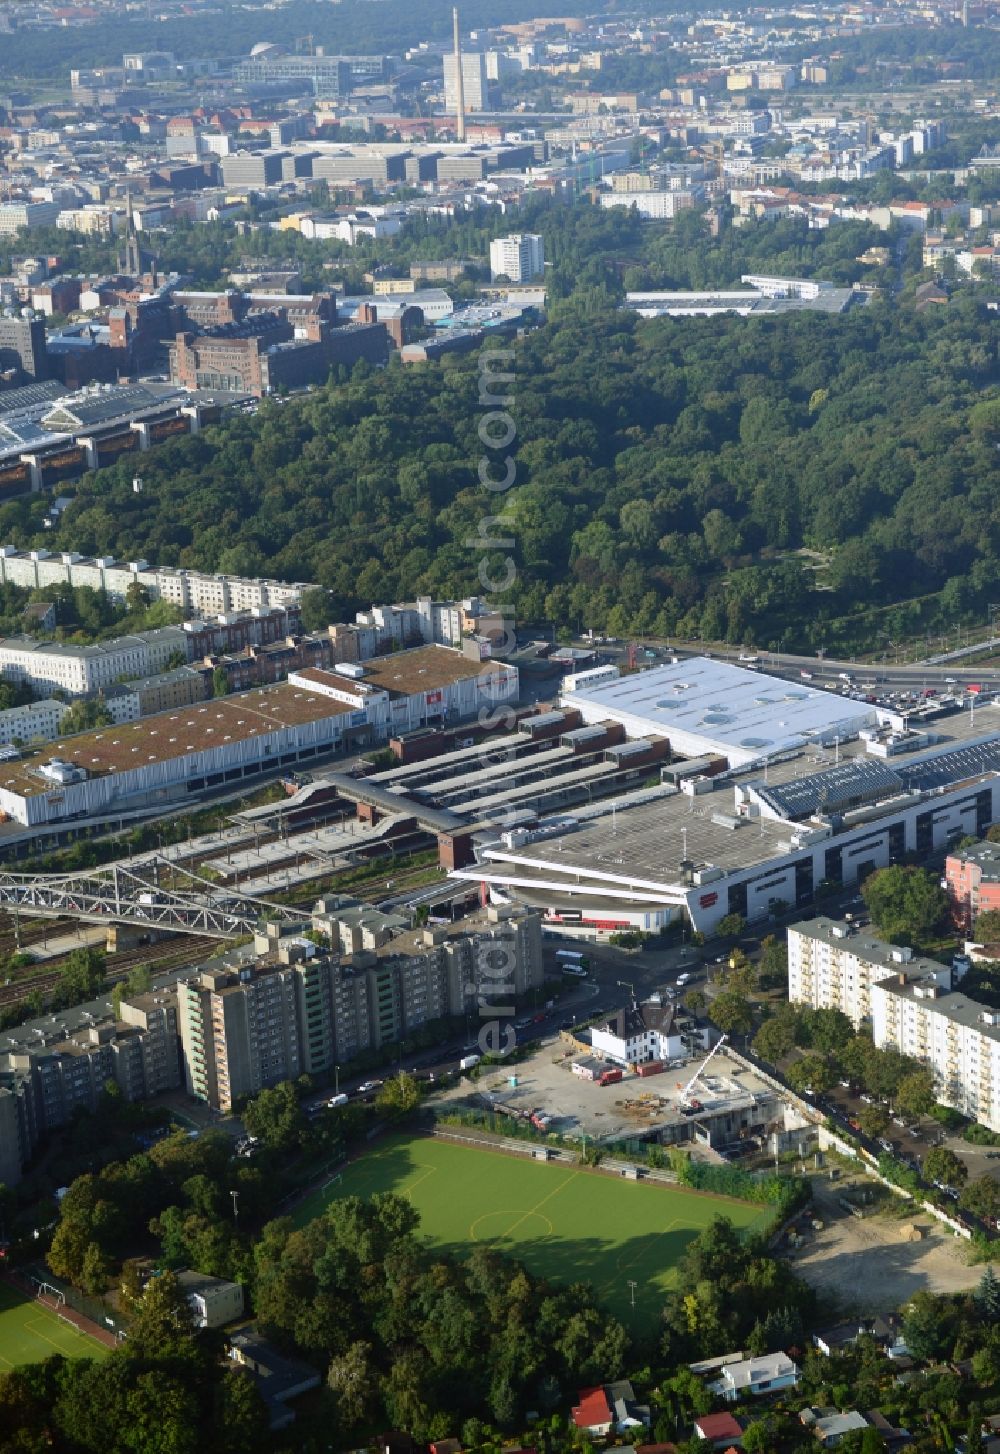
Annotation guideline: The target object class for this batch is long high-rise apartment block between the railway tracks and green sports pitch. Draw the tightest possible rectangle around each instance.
[177,909,544,1111]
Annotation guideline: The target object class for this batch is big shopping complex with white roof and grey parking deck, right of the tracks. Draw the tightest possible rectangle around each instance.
[455,662,1000,933]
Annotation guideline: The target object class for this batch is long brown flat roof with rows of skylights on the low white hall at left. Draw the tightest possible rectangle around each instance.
[0,682,352,797]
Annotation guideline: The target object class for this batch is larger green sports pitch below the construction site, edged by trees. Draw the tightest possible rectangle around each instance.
[295,1136,773,1333]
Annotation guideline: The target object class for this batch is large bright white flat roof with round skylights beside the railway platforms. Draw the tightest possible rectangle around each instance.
[561,656,875,765]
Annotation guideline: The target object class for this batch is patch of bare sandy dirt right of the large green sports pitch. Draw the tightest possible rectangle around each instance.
[789,1178,983,1313]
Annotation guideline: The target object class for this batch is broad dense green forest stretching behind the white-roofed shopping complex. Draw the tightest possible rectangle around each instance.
[0,205,1000,650]
